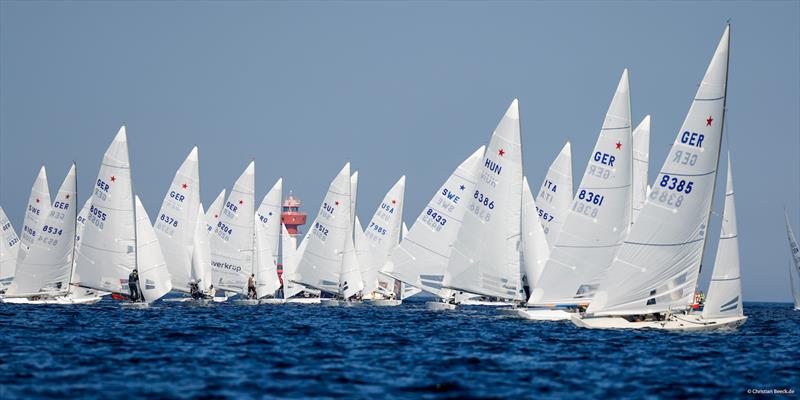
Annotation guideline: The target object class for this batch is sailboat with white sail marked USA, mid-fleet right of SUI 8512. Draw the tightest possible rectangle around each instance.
[356,176,406,306]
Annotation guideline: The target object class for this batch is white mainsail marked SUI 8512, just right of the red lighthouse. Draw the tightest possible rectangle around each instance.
[284,163,353,295]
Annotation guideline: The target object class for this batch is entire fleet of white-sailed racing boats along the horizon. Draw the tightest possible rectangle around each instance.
[0,26,800,330]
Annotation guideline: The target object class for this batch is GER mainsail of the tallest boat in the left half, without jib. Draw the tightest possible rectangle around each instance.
[74,126,136,295]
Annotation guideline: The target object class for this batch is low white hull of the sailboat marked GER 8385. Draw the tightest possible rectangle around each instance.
[571,314,747,332]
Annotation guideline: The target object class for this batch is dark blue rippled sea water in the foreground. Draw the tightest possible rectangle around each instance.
[0,300,800,399]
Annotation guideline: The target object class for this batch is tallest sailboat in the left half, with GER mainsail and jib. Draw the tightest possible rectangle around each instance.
[73,126,172,307]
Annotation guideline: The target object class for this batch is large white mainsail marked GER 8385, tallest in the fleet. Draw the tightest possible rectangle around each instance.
[587,27,729,315]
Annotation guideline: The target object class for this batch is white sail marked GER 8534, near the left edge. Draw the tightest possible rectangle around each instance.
[6,164,78,296]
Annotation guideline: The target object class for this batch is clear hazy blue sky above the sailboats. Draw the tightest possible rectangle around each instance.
[0,1,800,301]
